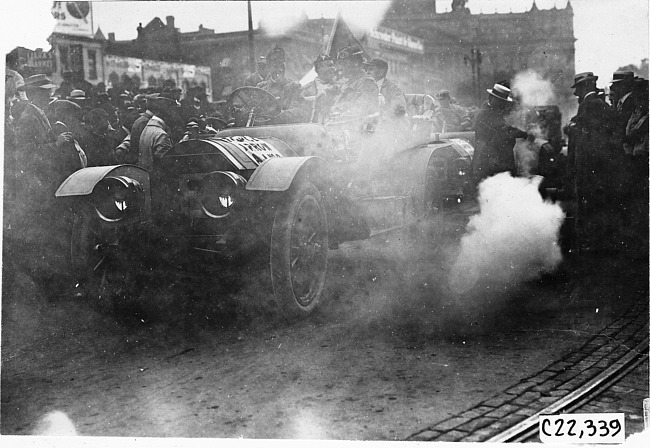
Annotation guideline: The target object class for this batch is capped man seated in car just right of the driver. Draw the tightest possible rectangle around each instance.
[302,53,339,124]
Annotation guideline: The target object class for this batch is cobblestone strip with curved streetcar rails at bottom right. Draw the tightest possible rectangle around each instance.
[408,300,648,442]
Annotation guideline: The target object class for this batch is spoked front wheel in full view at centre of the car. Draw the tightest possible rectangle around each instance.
[271,182,329,318]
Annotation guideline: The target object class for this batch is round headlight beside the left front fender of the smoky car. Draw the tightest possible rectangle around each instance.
[93,176,144,222]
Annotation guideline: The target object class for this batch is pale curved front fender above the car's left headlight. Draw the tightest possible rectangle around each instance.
[55,165,151,214]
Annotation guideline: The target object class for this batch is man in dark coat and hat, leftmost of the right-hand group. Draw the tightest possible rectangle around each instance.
[568,72,623,250]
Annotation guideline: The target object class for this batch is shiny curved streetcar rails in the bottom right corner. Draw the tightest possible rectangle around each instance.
[485,337,648,443]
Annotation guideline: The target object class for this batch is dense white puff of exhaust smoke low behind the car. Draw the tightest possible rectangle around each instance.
[448,173,564,294]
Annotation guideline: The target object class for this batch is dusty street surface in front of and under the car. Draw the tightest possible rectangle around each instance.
[1,234,648,440]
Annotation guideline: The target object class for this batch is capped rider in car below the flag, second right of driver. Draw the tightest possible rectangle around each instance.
[329,46,379,125]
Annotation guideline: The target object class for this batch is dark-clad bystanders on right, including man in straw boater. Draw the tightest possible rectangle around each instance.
[472,71,649,255]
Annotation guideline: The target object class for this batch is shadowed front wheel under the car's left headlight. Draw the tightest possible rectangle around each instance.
[70,210,138,312]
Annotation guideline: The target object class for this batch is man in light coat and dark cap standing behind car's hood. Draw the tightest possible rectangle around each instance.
[137,96,178,171]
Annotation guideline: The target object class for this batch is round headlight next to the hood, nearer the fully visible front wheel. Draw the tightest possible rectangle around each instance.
[190,171,246,219]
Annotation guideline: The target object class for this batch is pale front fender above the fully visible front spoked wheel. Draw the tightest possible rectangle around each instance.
[246,156,325,191]
